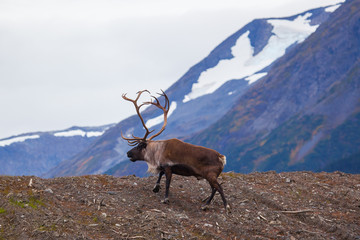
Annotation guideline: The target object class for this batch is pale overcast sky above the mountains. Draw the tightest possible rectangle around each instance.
[0,0,340,139]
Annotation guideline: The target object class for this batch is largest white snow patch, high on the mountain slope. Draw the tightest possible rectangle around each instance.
[183,13,318,103]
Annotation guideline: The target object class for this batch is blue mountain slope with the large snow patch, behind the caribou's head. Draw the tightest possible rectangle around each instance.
[46,3,342,177]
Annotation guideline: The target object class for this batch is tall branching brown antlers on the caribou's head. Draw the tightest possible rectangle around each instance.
[121,90,170,146]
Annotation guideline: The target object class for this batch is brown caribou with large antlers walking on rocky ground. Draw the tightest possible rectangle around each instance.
[121,90,230,213]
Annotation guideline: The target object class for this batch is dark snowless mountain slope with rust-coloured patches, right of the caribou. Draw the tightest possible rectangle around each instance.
[188,1,360,172]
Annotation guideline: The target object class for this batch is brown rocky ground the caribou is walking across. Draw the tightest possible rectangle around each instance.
[0,172,360,240]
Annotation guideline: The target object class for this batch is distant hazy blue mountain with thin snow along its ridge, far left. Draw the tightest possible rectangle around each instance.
[0,125,112,176]
